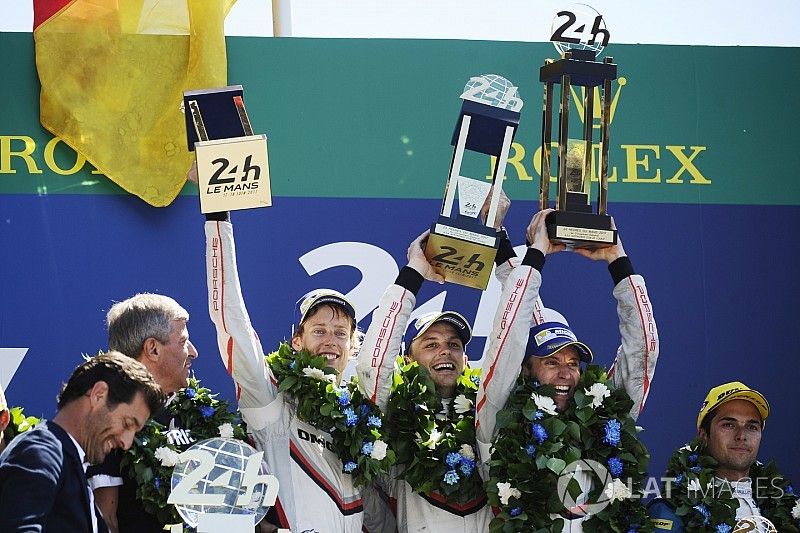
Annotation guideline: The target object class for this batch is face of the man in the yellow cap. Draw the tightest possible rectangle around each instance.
[700,400,762,481]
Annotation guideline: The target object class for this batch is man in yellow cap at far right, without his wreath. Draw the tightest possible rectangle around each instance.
[648,381,792,533]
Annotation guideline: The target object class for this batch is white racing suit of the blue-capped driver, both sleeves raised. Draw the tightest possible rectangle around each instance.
[475,249,659,532]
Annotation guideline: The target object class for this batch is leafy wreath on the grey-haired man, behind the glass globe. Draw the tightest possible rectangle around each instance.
[120,376,246,525]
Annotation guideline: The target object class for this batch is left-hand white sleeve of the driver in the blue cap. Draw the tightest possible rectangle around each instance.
[475,265,542,461]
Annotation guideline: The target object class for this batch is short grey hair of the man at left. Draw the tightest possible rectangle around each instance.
[106,292,189,359]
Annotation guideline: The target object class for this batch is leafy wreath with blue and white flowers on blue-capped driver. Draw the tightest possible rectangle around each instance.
[486,365,652,533]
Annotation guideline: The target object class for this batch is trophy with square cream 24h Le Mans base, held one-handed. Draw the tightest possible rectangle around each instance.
[183,85,272,213]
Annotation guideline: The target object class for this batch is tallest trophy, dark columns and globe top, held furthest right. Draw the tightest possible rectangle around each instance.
[539,4,617,248]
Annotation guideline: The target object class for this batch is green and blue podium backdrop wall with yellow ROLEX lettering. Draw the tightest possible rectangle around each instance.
[0,33,800,482]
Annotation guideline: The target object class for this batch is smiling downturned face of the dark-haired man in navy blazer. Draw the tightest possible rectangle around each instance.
[81,392,150,464]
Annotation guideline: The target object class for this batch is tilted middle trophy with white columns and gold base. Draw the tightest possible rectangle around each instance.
[425,74,522,290]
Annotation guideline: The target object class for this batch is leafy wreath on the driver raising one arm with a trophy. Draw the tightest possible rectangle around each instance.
[267,343,395,486]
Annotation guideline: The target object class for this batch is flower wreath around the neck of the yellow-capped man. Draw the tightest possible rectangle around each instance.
[665,438,800,533]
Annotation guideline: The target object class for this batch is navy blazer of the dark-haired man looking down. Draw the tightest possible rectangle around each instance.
[0,421,108,533]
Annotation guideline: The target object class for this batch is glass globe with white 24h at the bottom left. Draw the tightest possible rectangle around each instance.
[168,438,278,531]
